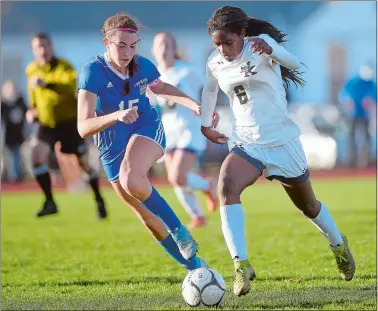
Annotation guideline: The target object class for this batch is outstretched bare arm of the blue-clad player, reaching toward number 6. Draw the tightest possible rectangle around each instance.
[149,80,201,115]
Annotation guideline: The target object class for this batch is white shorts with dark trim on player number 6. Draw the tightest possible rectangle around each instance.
[229,136,310,183]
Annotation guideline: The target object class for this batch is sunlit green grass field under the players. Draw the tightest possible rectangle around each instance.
[1,178,377,310]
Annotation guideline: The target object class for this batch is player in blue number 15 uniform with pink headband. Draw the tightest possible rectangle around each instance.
[78,12,206,270]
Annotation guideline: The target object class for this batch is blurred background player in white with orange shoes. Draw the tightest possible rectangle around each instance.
[150,32,219,228]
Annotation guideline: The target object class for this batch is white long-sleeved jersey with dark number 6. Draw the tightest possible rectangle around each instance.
[202,35,300,147]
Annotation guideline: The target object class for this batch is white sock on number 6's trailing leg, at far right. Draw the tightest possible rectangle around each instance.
[308,203,343,247]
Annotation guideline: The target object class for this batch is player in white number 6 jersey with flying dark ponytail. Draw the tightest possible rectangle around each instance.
[201,6,356,296]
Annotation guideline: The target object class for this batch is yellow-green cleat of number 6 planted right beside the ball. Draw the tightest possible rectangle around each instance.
[234,259,256,296]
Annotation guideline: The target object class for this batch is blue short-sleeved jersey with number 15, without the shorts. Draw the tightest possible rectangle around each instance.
[79,55,160,152]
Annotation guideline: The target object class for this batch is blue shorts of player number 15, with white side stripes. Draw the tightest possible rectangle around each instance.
[100,113,166,182]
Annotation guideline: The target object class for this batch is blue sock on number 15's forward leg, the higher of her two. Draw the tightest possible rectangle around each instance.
[142,187,181,232]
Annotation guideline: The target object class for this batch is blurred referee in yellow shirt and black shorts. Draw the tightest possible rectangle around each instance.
[25,33,107,218]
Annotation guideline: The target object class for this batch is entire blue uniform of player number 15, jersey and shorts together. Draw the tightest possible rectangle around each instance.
[78,54,165,180]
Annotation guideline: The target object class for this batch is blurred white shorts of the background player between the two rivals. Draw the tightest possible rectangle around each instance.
[163,118,207,156]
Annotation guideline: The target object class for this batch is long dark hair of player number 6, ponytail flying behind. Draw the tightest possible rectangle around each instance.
[207,6,306,89]
